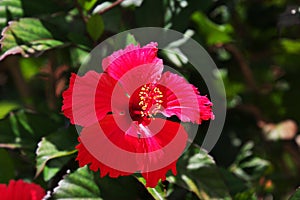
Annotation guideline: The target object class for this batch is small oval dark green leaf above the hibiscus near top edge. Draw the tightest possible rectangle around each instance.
[86,14,104,41]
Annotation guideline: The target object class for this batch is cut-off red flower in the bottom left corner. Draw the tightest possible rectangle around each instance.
[0,180,45,200]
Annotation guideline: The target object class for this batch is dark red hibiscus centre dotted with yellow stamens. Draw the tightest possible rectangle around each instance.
[129,83,163,124]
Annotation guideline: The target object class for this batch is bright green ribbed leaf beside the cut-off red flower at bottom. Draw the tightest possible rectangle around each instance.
[53,166,101,200]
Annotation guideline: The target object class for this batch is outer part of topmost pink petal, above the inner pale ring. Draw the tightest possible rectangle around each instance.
[102,42,162,80]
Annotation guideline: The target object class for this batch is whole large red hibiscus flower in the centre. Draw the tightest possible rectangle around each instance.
[62,43,214,187]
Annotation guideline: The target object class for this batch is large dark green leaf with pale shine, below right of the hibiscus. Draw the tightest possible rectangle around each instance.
[175,148,230,199]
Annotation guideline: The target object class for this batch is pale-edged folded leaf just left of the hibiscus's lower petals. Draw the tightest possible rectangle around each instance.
[36,138,76,179]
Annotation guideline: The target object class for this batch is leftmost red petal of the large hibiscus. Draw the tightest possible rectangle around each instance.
[62,71,116,126]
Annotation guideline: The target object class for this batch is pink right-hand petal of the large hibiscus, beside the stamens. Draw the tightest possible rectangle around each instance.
[158,72,213,124]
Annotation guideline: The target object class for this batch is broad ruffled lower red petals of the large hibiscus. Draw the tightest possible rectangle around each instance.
[77,115,187,186]
